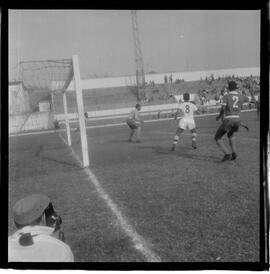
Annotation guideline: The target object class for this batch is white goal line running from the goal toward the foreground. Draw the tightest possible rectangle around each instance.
[59,135,161,262]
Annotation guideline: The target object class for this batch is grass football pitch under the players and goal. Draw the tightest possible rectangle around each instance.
[8,112,260,262]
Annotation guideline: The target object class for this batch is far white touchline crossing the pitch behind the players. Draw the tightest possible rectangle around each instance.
[9,109,256,137]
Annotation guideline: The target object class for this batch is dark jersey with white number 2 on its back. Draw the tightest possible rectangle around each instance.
[222,90,247,118]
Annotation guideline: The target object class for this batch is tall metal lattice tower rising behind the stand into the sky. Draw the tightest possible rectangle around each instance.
[131,10,145,96]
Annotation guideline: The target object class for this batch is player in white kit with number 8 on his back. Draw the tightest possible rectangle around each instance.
[171,93,198,151]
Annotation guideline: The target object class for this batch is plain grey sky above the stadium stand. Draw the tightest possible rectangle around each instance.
[9,10,260,80]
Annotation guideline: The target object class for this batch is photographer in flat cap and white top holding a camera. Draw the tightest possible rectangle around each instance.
[8,194,74,262]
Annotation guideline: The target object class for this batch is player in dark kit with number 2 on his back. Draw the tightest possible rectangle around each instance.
[215,81,248,162]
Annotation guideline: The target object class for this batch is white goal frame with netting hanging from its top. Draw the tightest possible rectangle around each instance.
[19,54,89,167]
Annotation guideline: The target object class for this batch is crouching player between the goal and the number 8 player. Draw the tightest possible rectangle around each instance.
[126,104,144,143]
